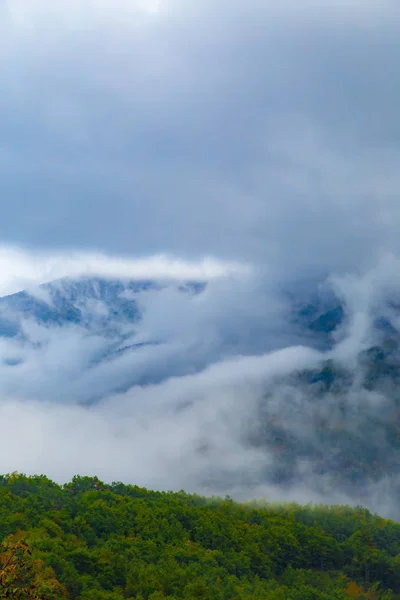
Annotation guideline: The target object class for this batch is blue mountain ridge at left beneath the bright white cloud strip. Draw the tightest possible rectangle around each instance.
[0,278,209,361]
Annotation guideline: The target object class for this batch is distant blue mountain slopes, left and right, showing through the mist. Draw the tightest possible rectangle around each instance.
[0,278,400,512]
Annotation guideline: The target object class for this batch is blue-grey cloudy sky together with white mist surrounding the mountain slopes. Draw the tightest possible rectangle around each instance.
[0,0,400,510]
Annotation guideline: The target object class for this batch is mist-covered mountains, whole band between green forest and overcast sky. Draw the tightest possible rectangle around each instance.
[0,260,400,516]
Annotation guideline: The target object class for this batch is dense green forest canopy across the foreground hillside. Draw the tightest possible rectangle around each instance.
[0,474,400,600]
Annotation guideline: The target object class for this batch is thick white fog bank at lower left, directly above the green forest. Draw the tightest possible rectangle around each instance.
[0,348,317,489]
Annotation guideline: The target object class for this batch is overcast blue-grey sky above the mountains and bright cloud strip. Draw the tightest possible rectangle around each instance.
[0,0,400,282]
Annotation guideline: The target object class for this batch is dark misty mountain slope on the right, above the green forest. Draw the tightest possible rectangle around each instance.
[245,292,400,510]
